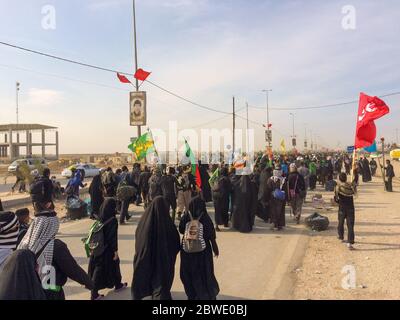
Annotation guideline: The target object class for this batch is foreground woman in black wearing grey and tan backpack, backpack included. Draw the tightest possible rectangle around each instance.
[179,196,219,300]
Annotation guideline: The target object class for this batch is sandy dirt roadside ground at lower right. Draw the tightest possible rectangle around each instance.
[293,162,400,300]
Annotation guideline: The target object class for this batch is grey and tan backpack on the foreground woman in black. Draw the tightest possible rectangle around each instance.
[182,212,206,253]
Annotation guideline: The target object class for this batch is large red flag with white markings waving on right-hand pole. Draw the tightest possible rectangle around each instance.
[354,92,389,149]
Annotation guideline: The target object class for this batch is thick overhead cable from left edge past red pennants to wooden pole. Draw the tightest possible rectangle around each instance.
[0,41,231,115]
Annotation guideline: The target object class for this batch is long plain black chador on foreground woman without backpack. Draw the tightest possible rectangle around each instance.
[132,196,180,300]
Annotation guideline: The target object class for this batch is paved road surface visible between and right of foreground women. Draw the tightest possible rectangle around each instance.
[58,205,311,300]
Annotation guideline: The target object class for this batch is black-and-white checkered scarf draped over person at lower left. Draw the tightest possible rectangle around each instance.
[18,216,60,278]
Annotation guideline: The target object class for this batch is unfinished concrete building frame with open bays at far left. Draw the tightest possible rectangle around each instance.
[0,124,59,161]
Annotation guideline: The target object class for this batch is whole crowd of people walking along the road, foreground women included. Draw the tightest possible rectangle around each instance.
[0,154,394,300]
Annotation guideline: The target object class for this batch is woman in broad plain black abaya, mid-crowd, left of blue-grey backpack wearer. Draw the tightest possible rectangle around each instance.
[232,175,257,233]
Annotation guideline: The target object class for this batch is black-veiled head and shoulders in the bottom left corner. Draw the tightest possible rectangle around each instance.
[0,249,46,300]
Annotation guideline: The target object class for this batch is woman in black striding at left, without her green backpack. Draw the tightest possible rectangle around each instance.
[88,198,128,300]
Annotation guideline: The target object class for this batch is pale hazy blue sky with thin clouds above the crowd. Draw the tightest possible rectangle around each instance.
[0,0,400,153]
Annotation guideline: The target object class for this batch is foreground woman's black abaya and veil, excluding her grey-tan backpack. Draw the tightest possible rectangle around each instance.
[179,196,219,300]
